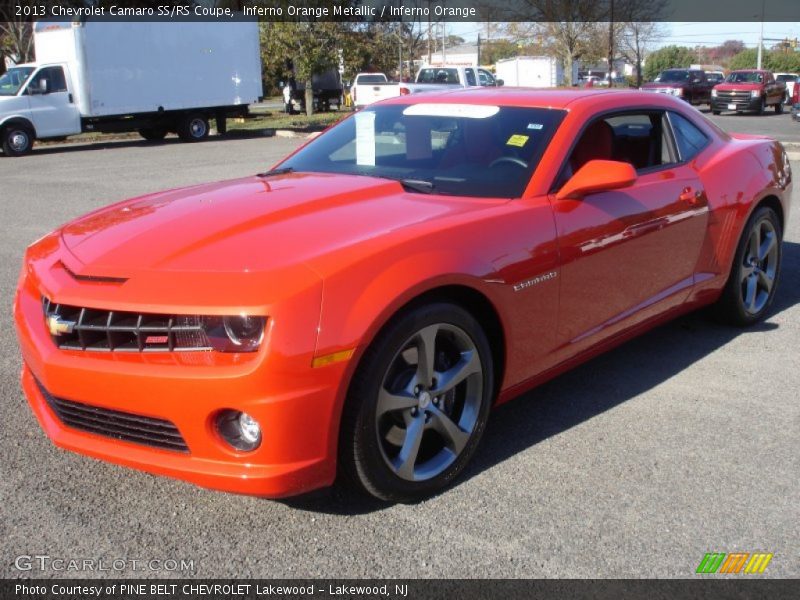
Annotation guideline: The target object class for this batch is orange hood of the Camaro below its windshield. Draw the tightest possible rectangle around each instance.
[60,173,494,277]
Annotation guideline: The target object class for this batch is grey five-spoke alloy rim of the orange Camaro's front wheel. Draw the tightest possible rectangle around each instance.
[375,323,483,481]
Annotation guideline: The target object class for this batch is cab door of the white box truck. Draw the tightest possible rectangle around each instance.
[27,66,81,138]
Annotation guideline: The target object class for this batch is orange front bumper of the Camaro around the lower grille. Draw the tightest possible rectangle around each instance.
[14,258,347,497]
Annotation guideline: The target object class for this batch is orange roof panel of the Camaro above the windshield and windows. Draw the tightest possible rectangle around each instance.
[381,86,676,109]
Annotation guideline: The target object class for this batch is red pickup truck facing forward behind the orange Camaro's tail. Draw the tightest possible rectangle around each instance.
[711,69,786,115]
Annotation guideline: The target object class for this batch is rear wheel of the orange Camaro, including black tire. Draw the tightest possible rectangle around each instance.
[713,206,783,327]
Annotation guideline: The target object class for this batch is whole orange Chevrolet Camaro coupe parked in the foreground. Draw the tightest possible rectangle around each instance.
[14,88,791,501]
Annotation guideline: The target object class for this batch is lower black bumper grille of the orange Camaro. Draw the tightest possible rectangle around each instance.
[36,380,189,452]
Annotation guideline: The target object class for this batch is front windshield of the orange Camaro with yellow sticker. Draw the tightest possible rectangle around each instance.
[280,103,566,198]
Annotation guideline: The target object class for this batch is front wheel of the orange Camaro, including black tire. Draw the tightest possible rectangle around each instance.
[339,303,494,502]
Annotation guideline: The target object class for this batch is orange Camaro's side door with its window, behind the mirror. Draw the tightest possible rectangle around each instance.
[551,110,708,354]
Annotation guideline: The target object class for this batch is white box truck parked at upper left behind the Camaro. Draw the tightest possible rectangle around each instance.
[0,20,263,156]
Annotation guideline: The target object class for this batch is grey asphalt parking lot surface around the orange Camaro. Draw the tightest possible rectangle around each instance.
[0,116,800,578]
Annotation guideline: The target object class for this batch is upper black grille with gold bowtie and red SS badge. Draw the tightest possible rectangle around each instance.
[42,297,211,352]
